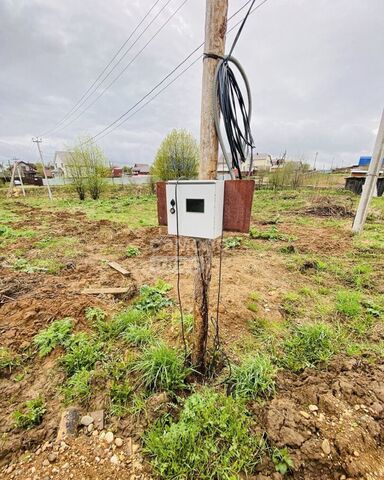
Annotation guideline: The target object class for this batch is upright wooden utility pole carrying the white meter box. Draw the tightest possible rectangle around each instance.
[192,0,228,373]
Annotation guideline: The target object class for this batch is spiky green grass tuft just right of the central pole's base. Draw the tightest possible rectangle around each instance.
[229,354,276,398]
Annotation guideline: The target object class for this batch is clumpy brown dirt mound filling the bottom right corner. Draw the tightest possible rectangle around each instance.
[258,358,384,480]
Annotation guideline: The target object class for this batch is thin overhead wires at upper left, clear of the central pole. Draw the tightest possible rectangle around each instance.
[39,0,169,135]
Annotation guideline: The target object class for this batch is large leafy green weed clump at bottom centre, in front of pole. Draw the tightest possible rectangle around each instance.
[145,390,265,480]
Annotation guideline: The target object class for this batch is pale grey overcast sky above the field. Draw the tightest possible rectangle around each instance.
[0,0,384,167]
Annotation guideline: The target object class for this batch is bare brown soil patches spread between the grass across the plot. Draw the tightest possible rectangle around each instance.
[0,197,384,480]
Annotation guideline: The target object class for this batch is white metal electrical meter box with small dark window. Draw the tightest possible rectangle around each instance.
[166,180,224,239]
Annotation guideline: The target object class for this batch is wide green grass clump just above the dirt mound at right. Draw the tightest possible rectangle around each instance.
[282,323,337,372]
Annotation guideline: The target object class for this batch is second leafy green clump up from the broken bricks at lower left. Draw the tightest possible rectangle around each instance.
[59,332,105,376]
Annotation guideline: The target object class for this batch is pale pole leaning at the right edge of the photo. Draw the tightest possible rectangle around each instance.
[352,110,384,233]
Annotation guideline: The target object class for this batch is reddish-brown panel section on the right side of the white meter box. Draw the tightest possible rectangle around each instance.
[223,180,255,233]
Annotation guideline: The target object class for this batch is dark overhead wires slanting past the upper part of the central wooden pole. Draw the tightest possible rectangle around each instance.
[89,0,268,141]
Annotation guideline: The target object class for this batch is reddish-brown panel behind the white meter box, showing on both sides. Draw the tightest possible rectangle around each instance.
[156,180,255,233]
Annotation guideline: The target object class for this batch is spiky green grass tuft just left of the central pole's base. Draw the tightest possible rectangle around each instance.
[131,343,190,391]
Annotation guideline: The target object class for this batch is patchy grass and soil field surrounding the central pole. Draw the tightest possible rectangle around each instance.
[0,185,384,479]
